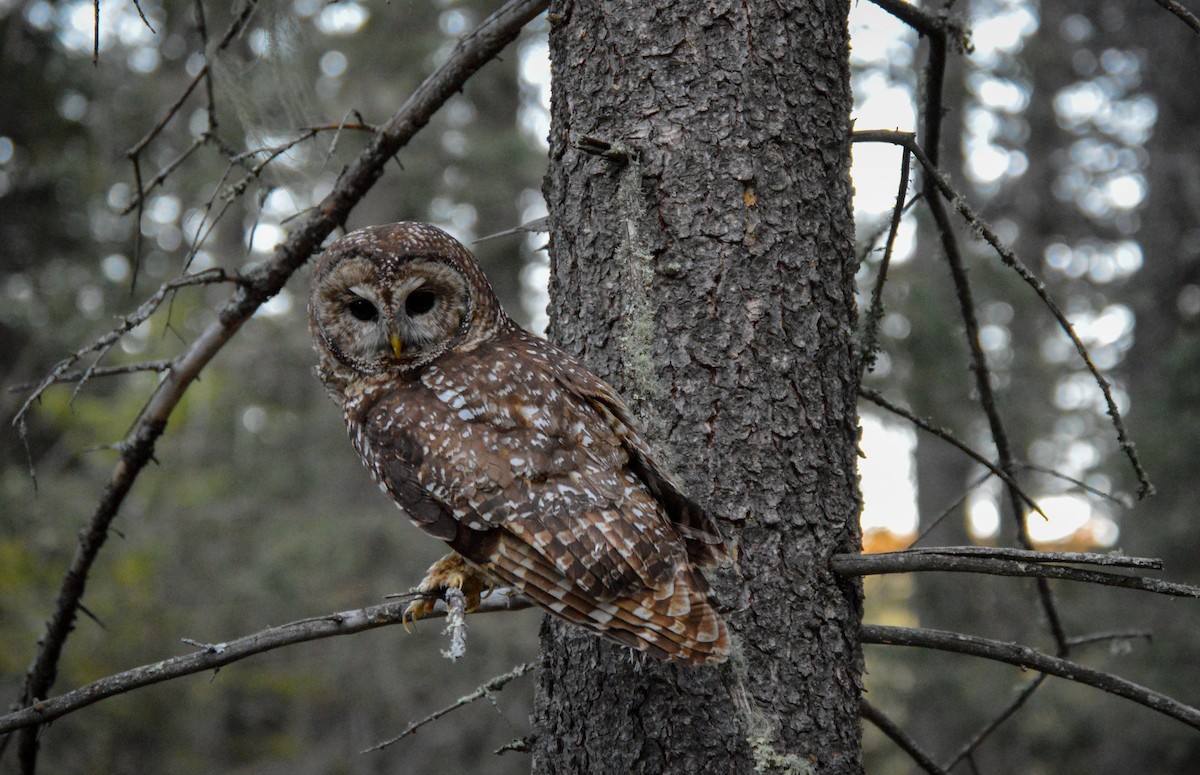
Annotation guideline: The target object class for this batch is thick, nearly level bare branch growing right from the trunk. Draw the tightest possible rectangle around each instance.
[829,549,1200,597]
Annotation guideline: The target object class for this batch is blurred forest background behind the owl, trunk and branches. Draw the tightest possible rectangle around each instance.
[0,0,1200,773]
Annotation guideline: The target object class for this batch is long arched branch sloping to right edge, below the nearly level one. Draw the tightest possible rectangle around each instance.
[862,624,1200,729]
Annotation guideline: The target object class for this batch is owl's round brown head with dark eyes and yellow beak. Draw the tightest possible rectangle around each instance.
[308,223,508,377]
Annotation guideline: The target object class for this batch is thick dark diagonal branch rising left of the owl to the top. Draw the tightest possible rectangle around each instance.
[12,0,547,771]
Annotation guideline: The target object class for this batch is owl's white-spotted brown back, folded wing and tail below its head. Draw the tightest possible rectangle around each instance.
[362,337,727,661]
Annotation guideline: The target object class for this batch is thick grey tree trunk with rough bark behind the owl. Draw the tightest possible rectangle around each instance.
[533,0,862,773]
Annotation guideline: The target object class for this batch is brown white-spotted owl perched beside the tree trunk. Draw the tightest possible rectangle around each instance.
[308,223,730,663]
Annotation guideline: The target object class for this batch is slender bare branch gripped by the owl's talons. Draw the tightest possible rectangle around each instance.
[0,589,532,733]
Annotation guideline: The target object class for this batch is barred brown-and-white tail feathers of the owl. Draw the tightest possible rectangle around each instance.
[488,540,730,665]
